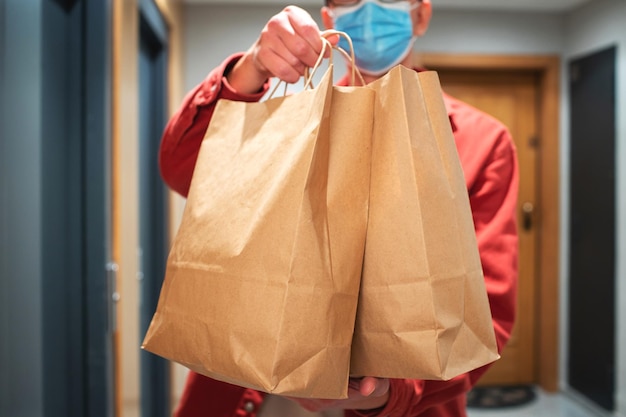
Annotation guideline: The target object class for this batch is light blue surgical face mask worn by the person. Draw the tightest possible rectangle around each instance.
[332,0,415,76]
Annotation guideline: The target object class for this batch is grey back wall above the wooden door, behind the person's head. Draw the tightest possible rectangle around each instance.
[184,5,563,89]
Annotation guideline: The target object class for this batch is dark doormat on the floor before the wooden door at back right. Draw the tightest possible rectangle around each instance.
[467,385,536,408]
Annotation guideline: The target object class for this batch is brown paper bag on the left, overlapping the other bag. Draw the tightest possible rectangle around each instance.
[143,66,374,398]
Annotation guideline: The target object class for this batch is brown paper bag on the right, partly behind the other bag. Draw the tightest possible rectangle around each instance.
[351,66,498,380]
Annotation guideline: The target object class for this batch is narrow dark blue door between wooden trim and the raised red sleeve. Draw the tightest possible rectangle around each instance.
[139,0,170,417]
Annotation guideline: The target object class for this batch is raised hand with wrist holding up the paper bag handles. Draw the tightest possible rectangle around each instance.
[227,6,338,93]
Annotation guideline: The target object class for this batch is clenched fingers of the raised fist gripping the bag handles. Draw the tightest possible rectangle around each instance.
[252,6,323,83]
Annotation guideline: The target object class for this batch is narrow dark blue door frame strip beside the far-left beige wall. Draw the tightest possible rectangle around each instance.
[82,0,116,417]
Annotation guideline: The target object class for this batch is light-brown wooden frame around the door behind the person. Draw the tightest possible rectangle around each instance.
[414,53,561,392]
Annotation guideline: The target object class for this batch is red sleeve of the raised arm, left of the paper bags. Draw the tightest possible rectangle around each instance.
[159,53,269,197]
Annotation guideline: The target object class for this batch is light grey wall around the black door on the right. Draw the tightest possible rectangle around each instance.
[562,0,626,416]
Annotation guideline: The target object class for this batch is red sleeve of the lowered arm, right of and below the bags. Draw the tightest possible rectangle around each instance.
[347,109,519,417]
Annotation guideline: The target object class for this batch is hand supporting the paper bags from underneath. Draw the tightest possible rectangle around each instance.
[290,377,389,412]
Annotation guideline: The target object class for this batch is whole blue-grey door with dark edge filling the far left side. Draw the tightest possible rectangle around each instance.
[0,0,113,417]
